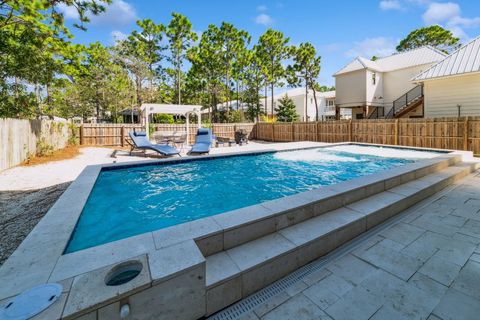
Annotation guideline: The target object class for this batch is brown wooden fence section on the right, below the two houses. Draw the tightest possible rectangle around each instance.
[255,117,480,154]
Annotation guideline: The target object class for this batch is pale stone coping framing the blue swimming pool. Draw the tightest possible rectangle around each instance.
[0,142,472,316]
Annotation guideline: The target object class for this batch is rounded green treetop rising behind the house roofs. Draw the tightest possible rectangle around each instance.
[397,25,460,53]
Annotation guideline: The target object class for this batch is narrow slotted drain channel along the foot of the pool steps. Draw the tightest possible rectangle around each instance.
[207,182,456,320]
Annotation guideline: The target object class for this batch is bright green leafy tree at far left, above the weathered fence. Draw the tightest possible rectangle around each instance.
[0,0,111,117]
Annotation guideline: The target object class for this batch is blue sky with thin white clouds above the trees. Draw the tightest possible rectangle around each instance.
[61,0,480,85]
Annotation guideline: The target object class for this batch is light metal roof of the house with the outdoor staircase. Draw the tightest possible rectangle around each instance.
[334,46,446,76]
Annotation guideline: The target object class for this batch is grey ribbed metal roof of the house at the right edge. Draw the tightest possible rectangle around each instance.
[412,36,480,81]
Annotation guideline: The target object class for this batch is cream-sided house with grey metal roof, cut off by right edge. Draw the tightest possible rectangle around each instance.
[412,36,480,117]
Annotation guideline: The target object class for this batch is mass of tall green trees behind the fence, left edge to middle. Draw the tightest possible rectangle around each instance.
[0,4,320,122]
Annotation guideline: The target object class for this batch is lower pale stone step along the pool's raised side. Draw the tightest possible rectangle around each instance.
[206,163,478,315]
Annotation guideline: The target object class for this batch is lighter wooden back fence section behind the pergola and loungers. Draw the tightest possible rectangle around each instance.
[79,123,255,147]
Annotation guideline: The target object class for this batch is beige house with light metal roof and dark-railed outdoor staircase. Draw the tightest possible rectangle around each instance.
[333,46,446,119]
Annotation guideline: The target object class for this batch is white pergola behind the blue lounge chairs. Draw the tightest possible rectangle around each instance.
[140,103,202,138]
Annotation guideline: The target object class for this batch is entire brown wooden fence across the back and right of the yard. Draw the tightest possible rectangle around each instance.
[80,117,480,154]
